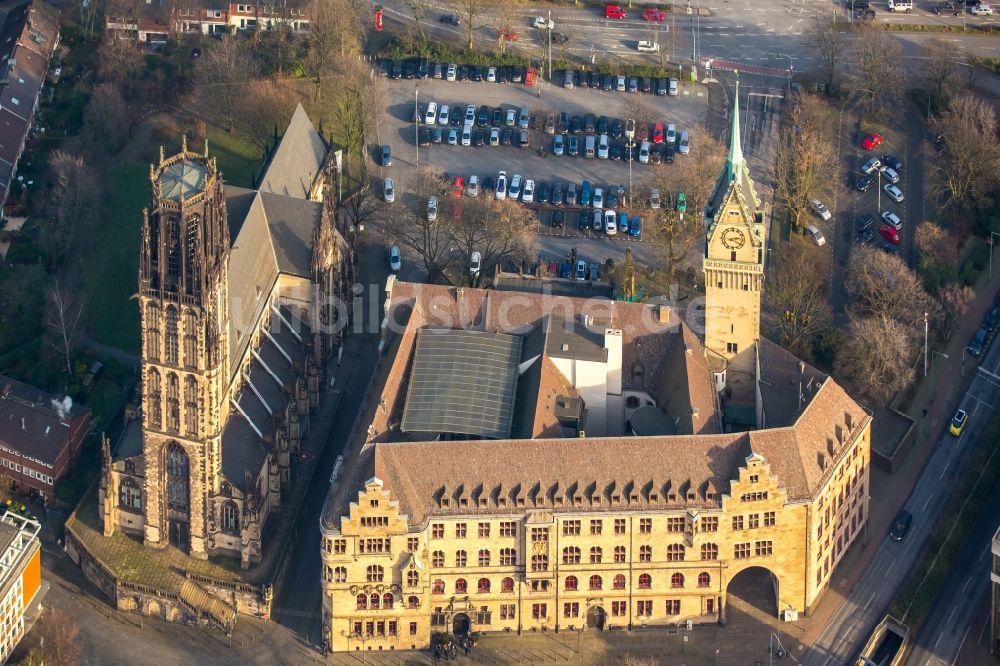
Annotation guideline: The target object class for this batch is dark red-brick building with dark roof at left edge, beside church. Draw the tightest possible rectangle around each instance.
[0,375,90,501]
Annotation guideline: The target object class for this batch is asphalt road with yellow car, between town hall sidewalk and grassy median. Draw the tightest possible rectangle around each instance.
[800,338,1000,666]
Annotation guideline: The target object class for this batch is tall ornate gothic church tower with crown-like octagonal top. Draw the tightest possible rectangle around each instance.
[139,138,230,557]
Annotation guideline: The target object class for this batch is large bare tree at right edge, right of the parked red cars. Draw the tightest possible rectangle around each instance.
[927,92,1000,210]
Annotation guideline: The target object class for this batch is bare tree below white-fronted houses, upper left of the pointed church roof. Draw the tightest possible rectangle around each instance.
[197,36,259,132]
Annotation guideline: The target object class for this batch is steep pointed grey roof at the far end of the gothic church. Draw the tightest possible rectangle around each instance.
[258,104,326,199]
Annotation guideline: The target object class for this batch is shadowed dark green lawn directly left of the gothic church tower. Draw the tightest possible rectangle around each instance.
[83,162,149,353]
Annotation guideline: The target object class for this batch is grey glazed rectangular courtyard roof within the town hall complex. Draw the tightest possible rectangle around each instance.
[401,329,521,439]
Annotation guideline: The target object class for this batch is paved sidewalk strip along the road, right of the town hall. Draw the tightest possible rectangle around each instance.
[791,256,1000,655]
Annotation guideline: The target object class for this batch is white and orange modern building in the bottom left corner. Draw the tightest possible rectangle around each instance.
[0,511,42,663]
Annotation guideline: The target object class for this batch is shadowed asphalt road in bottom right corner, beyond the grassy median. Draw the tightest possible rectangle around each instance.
[906,478,1000,666]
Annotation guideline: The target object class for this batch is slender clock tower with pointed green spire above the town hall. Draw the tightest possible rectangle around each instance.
[702,82,766,374]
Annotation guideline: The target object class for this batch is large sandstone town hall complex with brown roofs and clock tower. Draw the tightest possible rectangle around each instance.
[319,83,871,652]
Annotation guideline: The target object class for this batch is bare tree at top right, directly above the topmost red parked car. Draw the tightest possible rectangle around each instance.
[847,23,906,114]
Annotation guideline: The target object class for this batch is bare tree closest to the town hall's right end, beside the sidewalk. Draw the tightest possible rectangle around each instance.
[834,315,914,404]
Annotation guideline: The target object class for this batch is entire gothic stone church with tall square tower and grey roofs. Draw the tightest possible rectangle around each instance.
[100,106,356,568]
